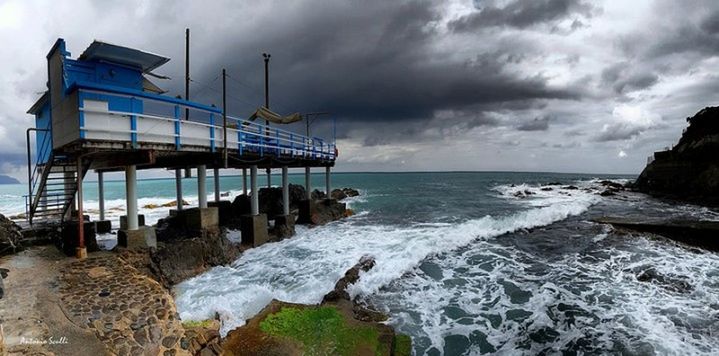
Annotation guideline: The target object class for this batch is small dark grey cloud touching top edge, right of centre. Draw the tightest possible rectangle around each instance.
[449,0,595,32]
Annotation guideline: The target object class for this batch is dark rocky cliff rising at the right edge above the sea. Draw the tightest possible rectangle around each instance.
[634,107,719,206]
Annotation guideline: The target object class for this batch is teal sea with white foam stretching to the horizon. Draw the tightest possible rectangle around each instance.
[0,172,719,355]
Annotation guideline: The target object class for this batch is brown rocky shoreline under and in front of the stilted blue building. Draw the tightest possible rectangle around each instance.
[0,185,411,356]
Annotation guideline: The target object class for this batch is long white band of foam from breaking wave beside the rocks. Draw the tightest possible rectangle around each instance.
[175,184,598,333]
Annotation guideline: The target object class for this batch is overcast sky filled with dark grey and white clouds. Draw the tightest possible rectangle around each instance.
[0,0,719,180]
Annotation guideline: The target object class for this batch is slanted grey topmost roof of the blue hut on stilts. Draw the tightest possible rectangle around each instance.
[78,40,170,73]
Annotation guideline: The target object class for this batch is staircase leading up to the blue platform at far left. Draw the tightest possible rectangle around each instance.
[26,154,90,224]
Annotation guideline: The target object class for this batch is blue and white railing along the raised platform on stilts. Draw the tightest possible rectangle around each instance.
[79,89,337,160]
